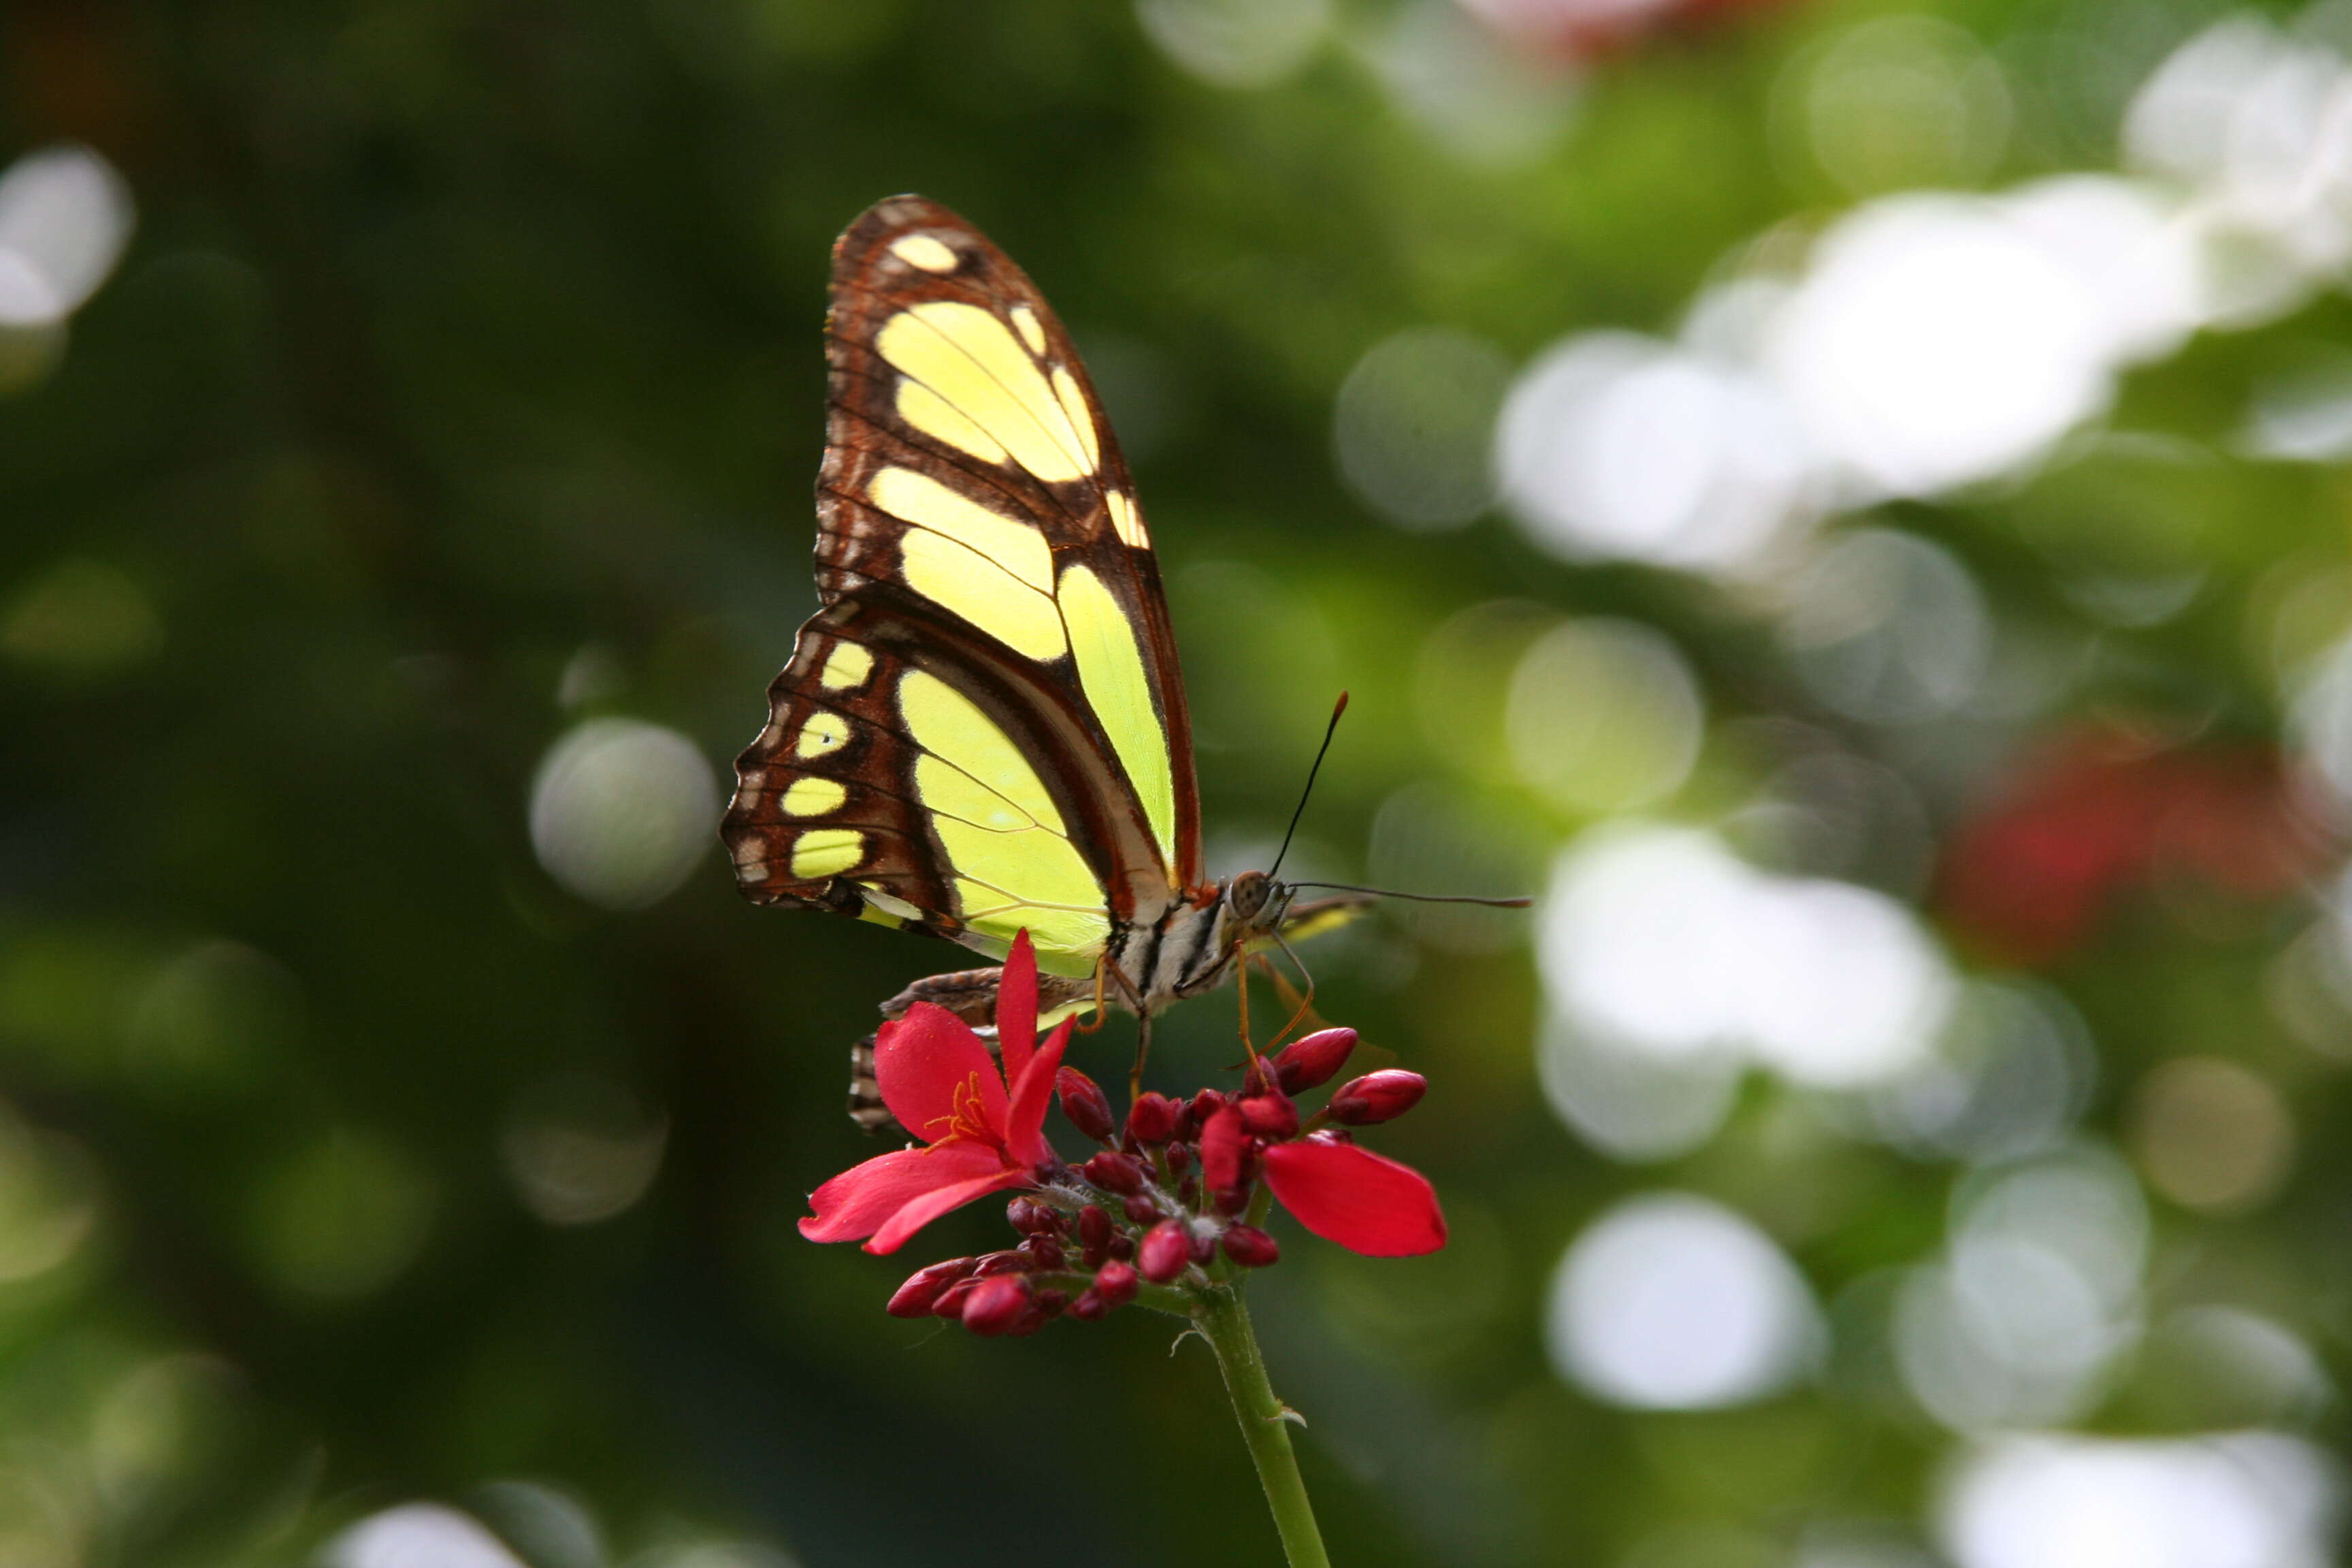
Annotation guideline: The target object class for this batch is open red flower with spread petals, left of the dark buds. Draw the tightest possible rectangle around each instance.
[800,931,1075,1253]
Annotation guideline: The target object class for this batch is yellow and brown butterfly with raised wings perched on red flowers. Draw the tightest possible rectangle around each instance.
[720,195,1364,1126]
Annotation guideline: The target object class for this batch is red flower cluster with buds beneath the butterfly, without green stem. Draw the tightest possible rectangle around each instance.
[800,933,1446,1335]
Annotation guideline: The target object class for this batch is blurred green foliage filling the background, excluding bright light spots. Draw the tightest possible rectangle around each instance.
[14,0,2352,1568]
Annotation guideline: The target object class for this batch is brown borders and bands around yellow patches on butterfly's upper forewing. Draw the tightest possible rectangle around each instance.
[816,195,1202,891]
